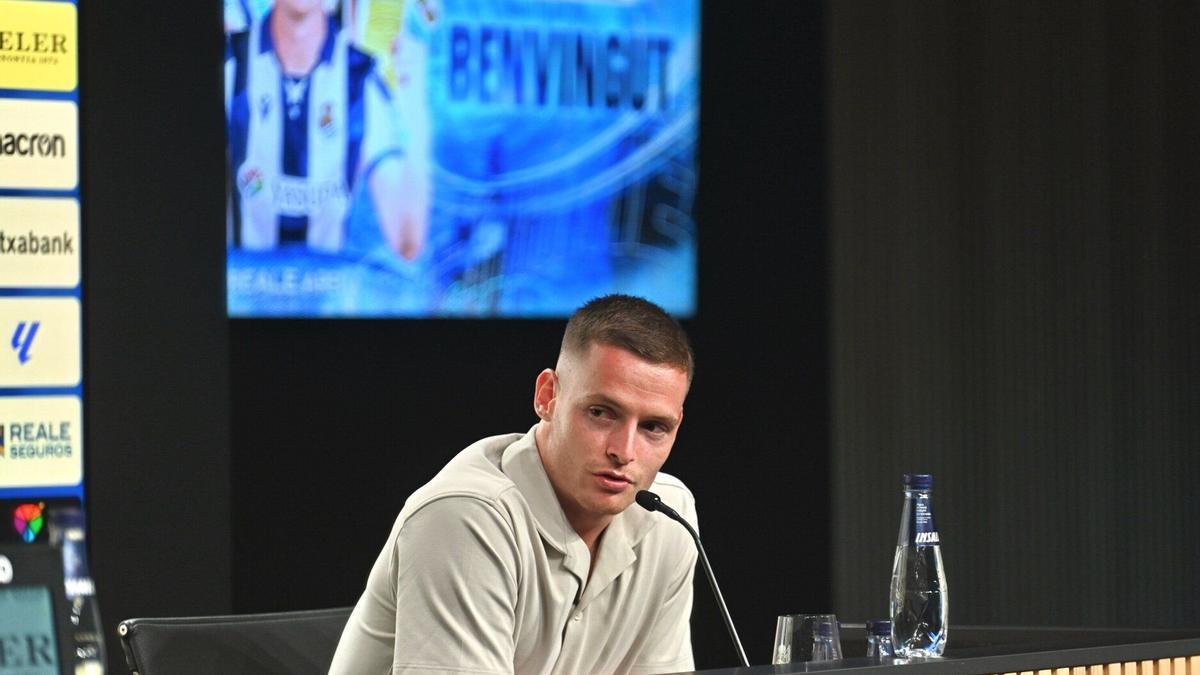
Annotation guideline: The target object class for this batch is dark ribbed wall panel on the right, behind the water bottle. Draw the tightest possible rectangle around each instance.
[829,2,1200,629]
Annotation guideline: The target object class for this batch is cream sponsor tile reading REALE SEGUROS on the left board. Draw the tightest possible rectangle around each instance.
[0,396,83,488]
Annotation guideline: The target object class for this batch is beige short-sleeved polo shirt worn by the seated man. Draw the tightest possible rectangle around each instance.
[330,430,696,675]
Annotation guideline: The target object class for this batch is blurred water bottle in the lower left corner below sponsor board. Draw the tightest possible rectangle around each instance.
[50,507,104,675]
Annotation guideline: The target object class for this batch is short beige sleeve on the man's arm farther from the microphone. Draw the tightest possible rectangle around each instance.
[392,497,518,674]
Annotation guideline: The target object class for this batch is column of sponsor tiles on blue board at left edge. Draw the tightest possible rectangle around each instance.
[0,0,84,544]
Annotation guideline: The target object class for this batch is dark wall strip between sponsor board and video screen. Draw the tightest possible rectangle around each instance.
[79,0,232,673]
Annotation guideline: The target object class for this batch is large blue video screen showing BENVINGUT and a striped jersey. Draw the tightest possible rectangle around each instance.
[224,0,700,317]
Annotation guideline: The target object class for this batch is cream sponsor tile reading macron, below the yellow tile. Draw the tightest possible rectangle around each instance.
[0,96,79,190]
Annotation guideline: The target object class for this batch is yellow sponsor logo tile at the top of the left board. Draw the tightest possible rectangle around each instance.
[0,0,79,91]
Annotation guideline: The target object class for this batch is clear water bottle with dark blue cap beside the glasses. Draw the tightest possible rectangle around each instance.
[890,473,950,658]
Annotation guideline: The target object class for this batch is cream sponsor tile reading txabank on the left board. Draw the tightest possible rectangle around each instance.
[0,197,79,288]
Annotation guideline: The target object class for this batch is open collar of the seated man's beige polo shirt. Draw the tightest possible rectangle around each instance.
[500,426,661,607]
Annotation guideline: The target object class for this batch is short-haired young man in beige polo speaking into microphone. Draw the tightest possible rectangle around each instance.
[330,295,696,675]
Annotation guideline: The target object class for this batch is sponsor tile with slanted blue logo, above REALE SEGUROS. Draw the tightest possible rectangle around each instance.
[0,298,80,386]
